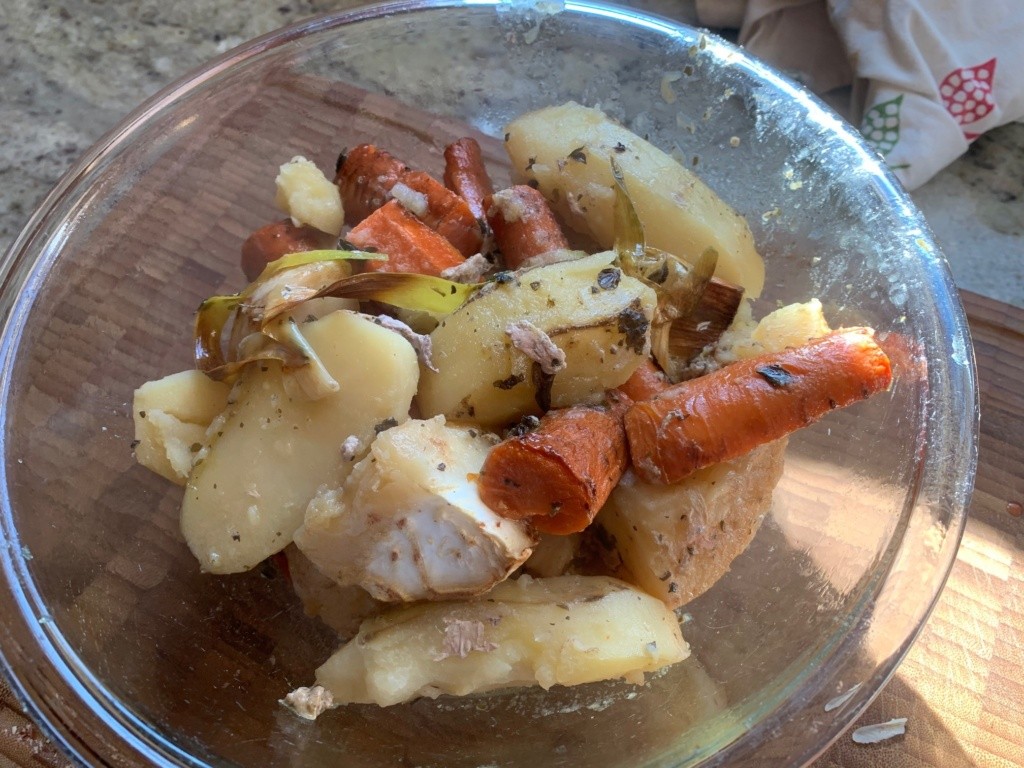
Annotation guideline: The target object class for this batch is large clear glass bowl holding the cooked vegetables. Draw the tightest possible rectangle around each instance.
[0,0,977,768]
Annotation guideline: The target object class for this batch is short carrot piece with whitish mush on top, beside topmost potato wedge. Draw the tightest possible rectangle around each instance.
[486,184,569,269]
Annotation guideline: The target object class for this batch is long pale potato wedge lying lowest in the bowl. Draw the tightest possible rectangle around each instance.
[316,575,689,707]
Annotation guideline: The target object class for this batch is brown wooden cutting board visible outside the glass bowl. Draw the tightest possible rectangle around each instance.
[0,292,1024,768]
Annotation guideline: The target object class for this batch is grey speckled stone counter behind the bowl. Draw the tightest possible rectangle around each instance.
[0,0,1024,306]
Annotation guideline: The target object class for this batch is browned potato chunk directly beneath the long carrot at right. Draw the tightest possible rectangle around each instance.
[594,439,785,608]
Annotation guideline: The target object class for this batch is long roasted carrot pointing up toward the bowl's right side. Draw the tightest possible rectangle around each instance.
[625,328,892,482]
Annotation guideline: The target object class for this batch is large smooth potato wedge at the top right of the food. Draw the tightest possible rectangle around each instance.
[505,101,765,297]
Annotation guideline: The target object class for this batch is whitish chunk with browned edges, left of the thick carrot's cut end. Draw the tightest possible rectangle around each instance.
[295,417,534,601]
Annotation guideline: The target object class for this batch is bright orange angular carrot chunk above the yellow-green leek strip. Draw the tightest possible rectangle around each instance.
[347,200,464,276]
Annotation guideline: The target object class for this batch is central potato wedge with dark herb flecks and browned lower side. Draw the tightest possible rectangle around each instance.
[418,253,656,427]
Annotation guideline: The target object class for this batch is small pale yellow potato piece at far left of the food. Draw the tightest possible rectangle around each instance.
[132,371,229,485]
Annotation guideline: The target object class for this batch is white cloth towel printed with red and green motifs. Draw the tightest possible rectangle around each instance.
[697,0,1024,189]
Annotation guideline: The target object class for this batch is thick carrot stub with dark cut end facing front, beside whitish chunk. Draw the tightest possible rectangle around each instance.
[477,392,630,535]
